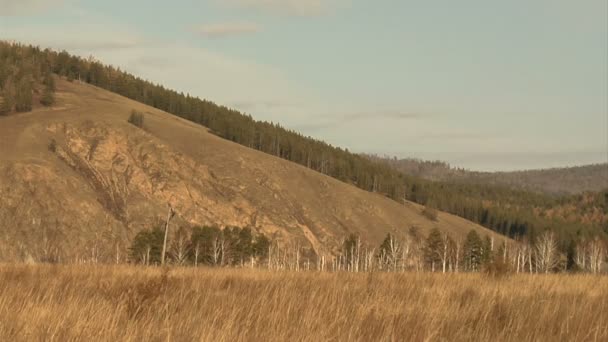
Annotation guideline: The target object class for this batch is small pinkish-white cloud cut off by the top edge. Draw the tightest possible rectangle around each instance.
[216,0,346,16]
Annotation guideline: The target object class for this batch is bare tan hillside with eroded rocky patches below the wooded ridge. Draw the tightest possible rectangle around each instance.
[0,80,504,260]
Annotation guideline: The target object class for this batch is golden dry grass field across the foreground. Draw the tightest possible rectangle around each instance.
[0,264,608,341]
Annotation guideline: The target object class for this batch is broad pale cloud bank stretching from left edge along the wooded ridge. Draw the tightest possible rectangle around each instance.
[0,21,310,120]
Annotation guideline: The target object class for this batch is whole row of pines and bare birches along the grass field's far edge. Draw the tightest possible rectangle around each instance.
[129,222,608,275]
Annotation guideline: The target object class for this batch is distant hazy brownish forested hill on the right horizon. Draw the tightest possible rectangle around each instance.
[367,155,608,195]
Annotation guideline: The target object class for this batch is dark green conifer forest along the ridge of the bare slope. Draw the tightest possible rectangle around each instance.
[0,42,605,254]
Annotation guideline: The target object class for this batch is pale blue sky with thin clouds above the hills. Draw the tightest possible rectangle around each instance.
[0,0,608,171]
